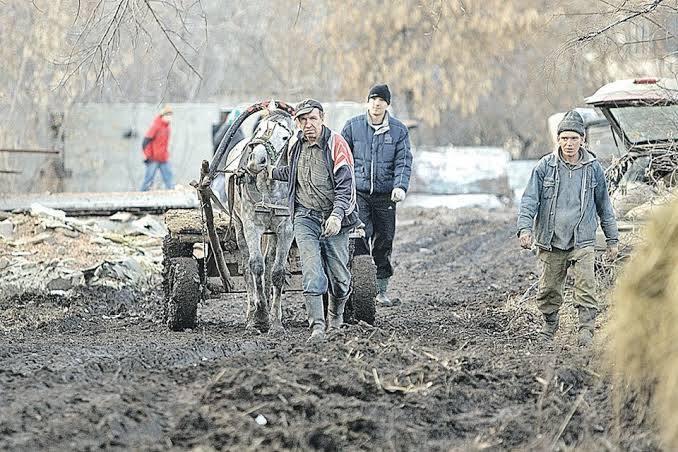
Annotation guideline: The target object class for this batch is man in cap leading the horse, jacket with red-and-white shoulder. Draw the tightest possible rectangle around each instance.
[270,99,360,343]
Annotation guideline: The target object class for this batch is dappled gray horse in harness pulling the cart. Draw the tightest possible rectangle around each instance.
[214,110,294,333]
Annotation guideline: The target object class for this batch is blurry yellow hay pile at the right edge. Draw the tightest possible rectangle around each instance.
[610,200,678,449]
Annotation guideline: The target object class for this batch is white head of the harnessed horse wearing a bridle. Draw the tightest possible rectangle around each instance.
[245,110,294,175]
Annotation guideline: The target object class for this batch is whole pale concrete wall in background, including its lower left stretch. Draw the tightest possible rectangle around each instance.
[0,102,366,193]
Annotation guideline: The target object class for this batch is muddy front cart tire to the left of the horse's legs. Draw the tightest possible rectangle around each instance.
[165,257,200,331]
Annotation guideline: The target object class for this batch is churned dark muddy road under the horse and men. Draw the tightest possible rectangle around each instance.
[0,209,659,451]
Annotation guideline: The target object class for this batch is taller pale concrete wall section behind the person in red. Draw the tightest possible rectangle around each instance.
[64,104,219,192]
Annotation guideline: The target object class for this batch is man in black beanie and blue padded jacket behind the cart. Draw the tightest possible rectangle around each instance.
[341,85,412,306]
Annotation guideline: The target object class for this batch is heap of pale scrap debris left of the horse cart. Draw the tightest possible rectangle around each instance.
[0,203,166,297]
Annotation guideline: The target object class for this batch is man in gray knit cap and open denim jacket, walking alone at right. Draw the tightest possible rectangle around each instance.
[518,110,618,346]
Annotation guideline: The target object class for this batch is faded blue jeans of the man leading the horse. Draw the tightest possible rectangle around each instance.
[294,206,351,299]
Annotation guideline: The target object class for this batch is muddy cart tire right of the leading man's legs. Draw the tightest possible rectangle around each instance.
[348,255,377,325]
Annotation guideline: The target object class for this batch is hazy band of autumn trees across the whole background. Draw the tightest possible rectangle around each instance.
[0,0,678,185]
